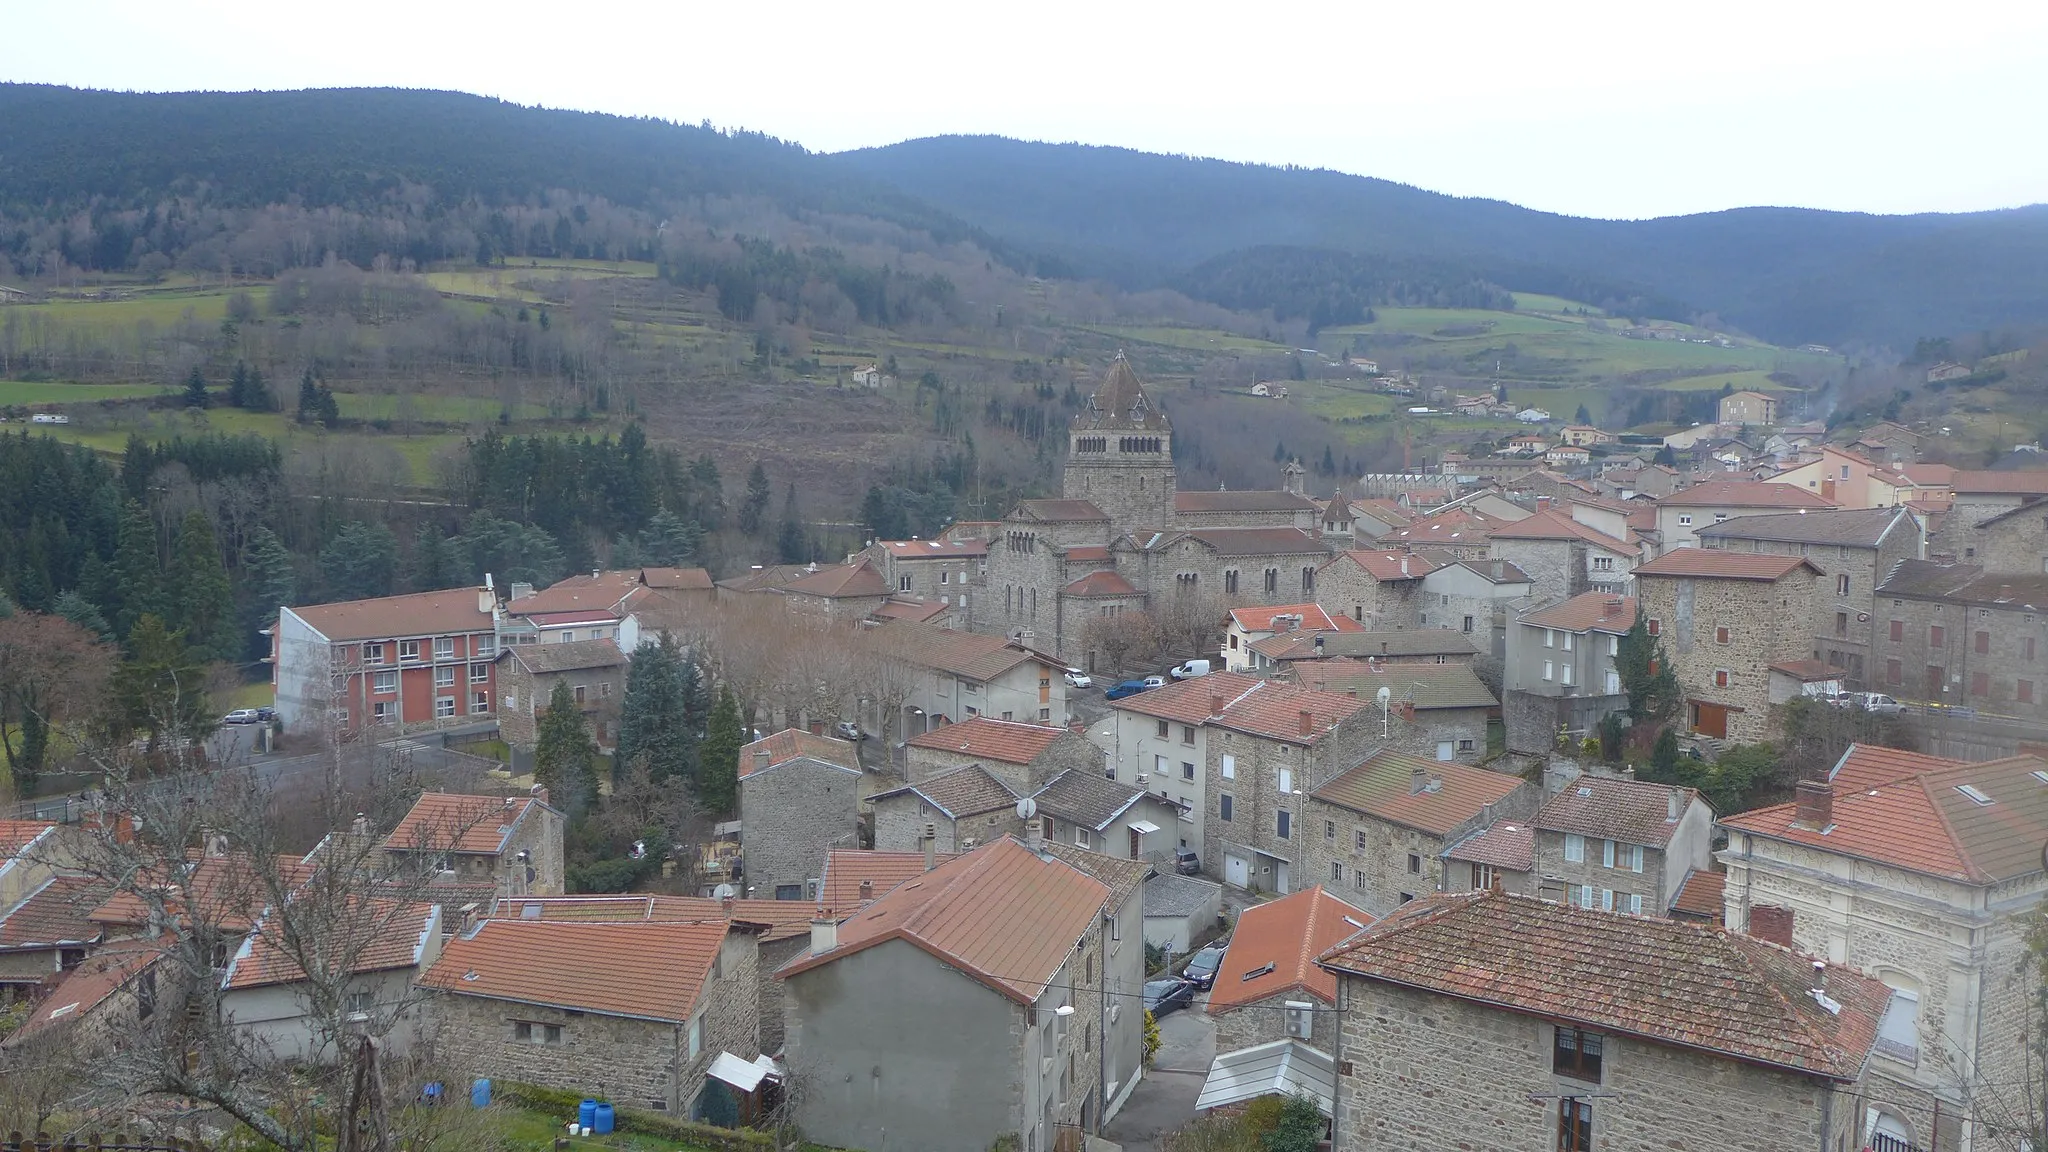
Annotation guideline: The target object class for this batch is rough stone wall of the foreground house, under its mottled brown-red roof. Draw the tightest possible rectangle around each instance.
[1335,978,1862,1152]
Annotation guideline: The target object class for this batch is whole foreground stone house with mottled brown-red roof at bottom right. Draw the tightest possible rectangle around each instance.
[1323,892,1888,1152]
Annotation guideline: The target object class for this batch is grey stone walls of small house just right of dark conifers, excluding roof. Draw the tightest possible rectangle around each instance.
[739,758,860,898]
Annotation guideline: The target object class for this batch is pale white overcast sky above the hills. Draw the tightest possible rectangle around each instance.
[0,0,2048,217]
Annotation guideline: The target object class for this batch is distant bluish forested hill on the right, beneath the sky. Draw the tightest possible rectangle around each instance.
[836,137,2048,344]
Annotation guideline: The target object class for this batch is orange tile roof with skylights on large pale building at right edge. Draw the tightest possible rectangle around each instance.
[1722,756,2048,883]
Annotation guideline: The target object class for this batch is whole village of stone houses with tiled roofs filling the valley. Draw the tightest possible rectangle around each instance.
[0,356,2048,1152]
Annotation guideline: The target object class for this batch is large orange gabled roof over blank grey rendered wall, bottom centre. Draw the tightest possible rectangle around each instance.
[776,836,1110,1004]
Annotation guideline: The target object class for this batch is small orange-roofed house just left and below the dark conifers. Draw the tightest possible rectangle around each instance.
[383,789,563,896]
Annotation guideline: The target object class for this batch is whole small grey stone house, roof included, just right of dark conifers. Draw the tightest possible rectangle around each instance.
[739,732,860,900]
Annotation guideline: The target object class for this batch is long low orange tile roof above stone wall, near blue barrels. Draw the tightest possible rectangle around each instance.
[420,920,727,1023]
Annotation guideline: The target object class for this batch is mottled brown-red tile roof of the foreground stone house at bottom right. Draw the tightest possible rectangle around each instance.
[1323,892,1890,1082]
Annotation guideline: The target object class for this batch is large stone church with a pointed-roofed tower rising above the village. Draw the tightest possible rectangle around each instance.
[967,353,1331,672]
